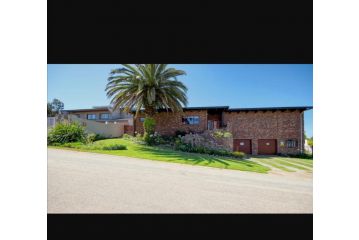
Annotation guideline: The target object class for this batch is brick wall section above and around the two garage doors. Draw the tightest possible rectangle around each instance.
[223,110,304,154]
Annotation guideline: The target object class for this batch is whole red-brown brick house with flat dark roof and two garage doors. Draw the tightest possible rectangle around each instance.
[134,106,312,155]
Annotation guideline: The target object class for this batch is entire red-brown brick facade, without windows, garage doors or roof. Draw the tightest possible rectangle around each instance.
[135,110,304,155]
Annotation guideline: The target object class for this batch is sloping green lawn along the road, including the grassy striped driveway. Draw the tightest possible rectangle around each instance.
[51,138,313,173]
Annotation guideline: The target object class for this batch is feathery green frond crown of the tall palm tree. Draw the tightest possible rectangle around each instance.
[106,64,187,117]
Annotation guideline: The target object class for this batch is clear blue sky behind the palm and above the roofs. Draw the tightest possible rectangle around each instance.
[48,64,313,136]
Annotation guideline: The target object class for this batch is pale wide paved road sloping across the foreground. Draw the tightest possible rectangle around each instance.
[47,149,313,213]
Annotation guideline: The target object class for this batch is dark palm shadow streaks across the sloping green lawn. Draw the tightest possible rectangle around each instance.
[136,146,262,168]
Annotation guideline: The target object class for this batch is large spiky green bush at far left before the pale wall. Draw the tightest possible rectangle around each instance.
[47,123,87,145]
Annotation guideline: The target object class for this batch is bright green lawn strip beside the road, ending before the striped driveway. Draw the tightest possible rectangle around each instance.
[52,139,270,173]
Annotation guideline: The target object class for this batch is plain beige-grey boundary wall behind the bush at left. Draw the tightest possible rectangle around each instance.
[68,114,127,137]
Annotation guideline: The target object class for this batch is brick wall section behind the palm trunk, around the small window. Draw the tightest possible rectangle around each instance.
[135,110,207,135]
